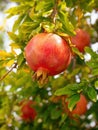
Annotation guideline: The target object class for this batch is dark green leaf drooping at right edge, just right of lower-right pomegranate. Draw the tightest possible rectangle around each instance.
[87,87,97,102]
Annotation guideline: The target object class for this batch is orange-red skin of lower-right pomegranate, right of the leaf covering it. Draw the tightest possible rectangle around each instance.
[71,94,87,115]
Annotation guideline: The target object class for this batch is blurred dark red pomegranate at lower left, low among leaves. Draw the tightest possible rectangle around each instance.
[21,100,37,121]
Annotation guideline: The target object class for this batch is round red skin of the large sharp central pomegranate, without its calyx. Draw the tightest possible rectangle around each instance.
[25,33,71,76]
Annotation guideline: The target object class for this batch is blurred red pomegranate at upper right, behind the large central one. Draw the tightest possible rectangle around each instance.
[71,29,90,52]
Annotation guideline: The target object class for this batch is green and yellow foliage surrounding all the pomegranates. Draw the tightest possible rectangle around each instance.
[0,0,98,130]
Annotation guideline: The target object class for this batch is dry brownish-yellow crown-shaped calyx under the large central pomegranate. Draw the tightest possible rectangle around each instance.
[32,69,48,88]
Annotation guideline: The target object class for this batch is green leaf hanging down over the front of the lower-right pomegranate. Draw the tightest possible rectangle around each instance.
[68,94,80,111]
